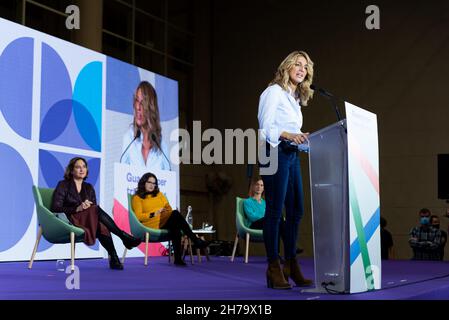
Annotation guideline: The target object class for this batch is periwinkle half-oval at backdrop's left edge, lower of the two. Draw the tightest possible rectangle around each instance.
[0,143,34,252]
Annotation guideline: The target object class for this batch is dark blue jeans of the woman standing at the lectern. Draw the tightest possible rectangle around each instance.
[262,142,304,261]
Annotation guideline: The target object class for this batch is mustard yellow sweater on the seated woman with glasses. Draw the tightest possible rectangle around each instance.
[131,192,173,229]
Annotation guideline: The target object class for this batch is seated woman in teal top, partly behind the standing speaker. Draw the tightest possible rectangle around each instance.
[243,177,284,238]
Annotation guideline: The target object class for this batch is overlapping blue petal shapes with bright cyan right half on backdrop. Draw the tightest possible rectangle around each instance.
[40,43,102,151]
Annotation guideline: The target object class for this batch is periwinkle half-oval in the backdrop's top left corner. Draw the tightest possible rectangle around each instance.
[0,38,34,139]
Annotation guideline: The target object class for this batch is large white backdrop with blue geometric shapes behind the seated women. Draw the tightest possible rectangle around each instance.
[0,18,179,261]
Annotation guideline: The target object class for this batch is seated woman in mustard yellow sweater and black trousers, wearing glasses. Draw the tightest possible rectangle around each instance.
[132,172,208,266]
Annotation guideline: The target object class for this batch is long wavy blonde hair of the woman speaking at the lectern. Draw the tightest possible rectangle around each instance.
[269,51,313,106]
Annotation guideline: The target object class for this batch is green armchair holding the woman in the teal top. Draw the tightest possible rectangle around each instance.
[231,197,263,263]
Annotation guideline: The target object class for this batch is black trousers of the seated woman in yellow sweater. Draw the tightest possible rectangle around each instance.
[161,210,198,260]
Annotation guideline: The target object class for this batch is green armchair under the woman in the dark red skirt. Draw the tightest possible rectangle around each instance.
[28,186,84,271]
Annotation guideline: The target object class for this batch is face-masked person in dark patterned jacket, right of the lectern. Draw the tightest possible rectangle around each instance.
[408,208,442,260]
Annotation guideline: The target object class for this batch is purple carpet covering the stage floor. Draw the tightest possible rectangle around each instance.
[0,257,449,300]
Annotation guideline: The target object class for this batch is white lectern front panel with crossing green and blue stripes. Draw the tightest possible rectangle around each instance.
[346,102,381,293]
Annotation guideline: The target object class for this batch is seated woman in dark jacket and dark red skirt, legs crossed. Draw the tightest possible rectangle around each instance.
[51,157,141,270]
